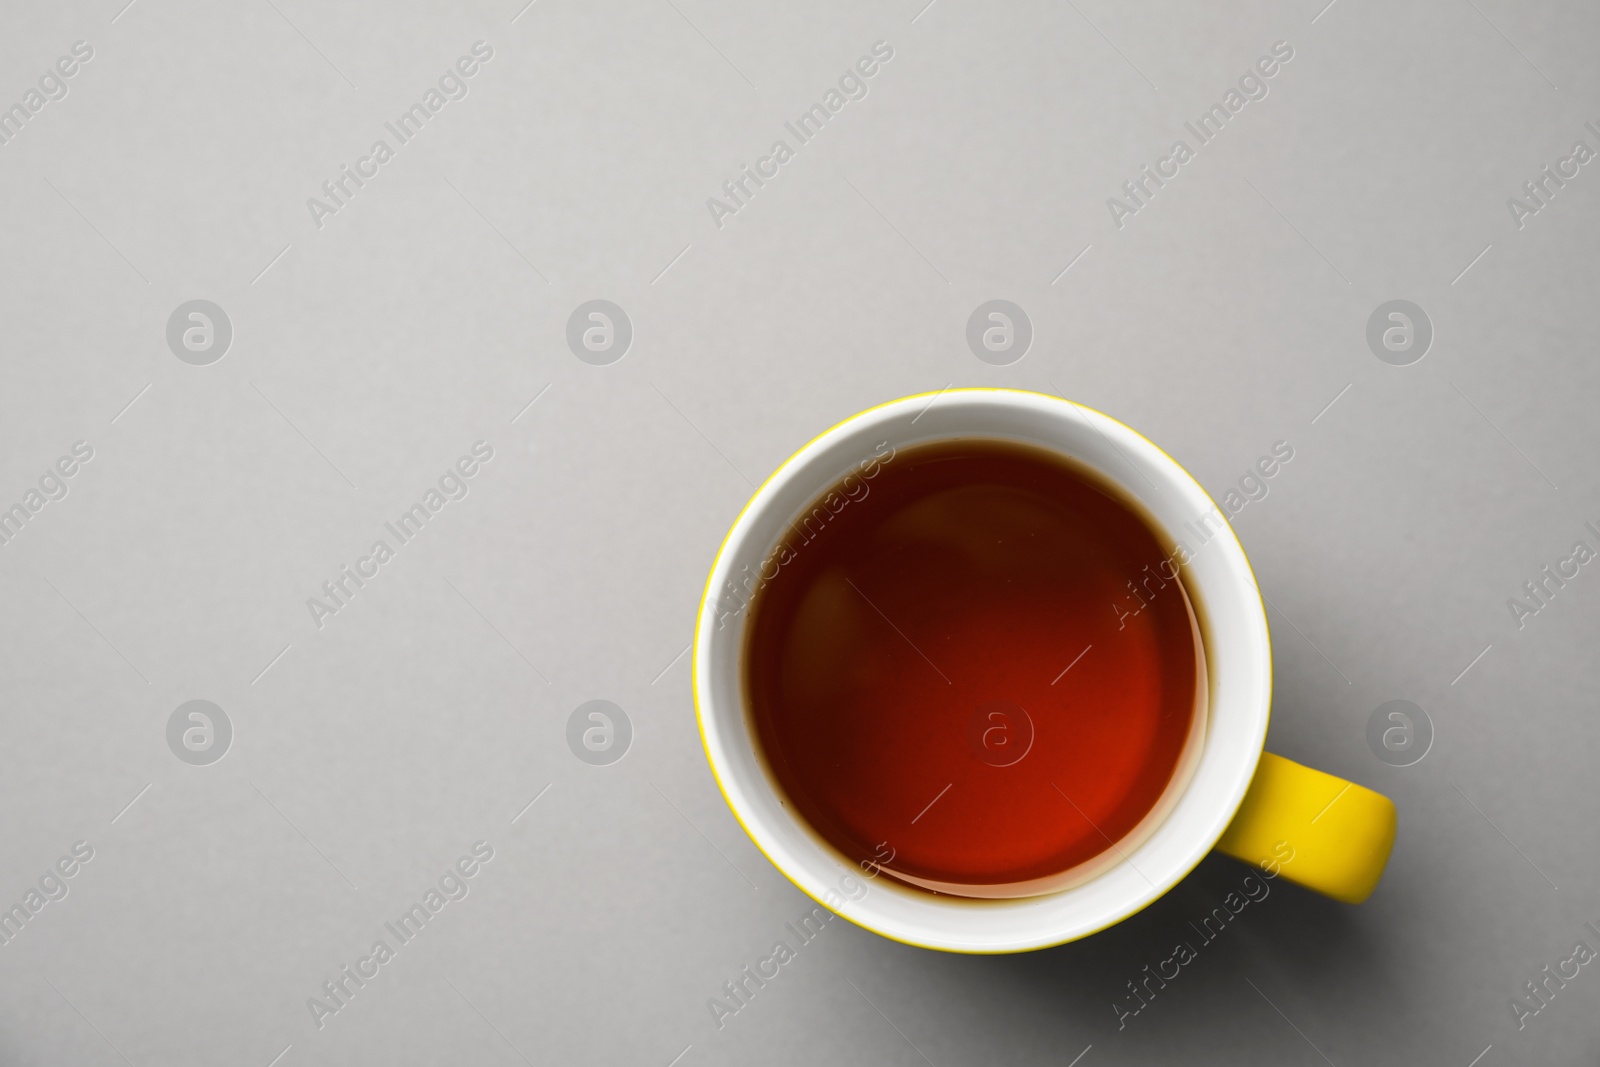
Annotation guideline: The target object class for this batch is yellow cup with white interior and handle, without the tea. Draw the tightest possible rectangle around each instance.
[693,389,1395,953]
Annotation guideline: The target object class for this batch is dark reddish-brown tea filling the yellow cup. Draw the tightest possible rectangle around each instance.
[744,440,1205,896]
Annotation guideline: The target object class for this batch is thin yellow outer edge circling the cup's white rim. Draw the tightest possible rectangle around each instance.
[690,386,1272,955]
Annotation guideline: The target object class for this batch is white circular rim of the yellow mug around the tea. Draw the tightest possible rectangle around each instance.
[690,387,1272,955]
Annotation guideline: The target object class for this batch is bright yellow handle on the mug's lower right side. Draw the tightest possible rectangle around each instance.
[1216,752,1395,904]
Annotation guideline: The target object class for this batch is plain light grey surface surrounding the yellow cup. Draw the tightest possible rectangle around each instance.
[0,0,1600,1067]
